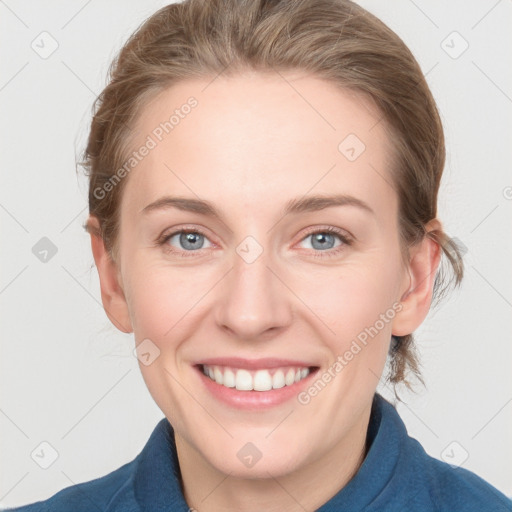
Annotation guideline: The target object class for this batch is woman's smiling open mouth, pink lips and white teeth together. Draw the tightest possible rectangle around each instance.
[194,358,320,410]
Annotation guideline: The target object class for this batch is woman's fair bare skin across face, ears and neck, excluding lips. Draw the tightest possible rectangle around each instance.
[90,73,441,511]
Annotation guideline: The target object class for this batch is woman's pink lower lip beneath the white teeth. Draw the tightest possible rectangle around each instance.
[196,367,318,410]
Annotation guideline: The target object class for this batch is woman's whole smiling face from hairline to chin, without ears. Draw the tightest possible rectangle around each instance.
[106,73,410,478]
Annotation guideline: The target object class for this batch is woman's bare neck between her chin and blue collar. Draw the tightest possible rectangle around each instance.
[175,407,371,512]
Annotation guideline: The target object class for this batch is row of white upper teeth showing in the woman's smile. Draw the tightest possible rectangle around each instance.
[203,365,309,391]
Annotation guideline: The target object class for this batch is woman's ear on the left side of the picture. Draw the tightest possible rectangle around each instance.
[87,215,133,333]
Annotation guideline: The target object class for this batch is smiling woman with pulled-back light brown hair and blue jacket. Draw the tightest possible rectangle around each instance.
[9,0,511,512]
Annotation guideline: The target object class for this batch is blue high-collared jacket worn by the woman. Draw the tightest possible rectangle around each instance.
[9,394,512,512]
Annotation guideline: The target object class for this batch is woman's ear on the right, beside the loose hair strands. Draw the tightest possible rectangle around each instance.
[392,219,442,336]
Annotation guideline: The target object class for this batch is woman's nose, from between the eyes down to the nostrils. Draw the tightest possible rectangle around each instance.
[212,242,293,341]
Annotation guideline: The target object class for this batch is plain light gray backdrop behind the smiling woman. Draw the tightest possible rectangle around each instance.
[0,0,512,506]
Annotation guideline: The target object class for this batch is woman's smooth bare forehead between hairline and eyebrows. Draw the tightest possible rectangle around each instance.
[123,69,395,218]
